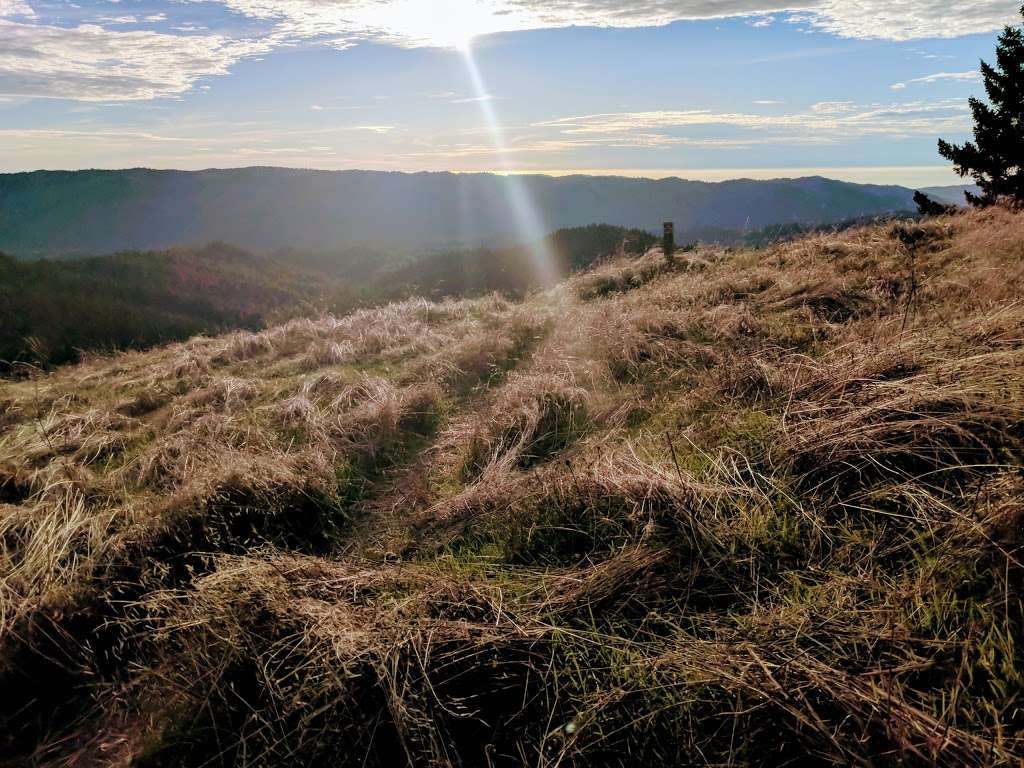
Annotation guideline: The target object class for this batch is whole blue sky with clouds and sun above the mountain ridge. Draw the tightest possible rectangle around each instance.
[0,0,1021,186]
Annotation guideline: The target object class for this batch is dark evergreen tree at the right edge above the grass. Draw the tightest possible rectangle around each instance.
[939,7,1024,206]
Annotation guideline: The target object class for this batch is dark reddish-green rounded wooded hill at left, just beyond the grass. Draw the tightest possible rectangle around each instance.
[0,243,331,375]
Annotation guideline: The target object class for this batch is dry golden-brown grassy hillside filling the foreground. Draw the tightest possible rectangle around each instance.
[0,209,1024,766]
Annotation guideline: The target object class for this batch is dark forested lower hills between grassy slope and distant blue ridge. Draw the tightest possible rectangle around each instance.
[0,224,654,376]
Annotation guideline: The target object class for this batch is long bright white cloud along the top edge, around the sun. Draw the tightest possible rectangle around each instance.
[205,0,1017,47]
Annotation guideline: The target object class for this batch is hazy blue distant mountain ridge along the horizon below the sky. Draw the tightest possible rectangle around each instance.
[0,168,954,255]
